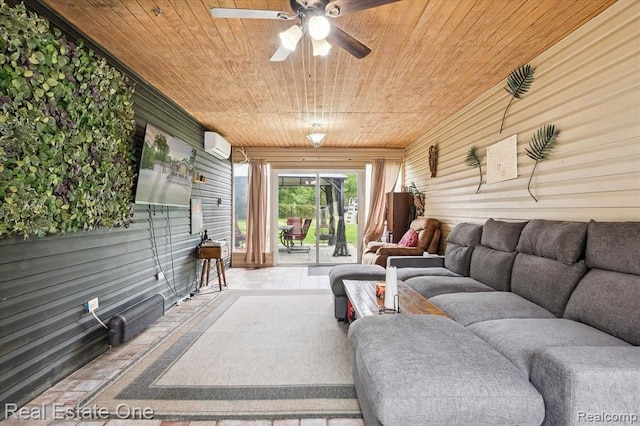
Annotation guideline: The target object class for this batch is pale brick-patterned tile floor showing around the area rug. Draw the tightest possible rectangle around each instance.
[1,266,364,426]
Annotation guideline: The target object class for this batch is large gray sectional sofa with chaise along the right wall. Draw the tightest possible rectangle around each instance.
[332,219,640,426]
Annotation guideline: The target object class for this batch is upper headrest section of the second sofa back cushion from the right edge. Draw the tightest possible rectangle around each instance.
[517,219,587,265]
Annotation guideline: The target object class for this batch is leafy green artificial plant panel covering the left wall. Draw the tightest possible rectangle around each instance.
[0,0,135,238]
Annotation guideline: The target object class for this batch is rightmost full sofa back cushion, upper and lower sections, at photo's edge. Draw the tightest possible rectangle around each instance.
[564,222,640,345]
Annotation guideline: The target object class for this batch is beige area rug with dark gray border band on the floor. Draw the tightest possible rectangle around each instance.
[85,290,361,420]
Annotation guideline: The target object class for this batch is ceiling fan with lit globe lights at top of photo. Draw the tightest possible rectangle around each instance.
[211,0,400,62]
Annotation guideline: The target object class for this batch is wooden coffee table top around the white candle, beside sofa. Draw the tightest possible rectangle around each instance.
[344,280,447,319]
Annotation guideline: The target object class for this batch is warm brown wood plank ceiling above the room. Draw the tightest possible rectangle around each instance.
[44,0,615,148]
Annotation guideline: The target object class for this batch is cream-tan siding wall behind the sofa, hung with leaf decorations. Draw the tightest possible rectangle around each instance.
[405,0,640,250]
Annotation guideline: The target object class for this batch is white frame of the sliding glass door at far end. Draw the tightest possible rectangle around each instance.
[269,168,366,266]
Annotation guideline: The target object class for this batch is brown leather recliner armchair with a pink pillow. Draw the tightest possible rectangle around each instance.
[362,217,440,268]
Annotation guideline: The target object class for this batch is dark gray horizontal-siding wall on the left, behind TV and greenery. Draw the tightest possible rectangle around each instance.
[0,2,232,419]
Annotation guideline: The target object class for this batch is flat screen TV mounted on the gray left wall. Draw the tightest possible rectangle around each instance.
[135,124,196,207]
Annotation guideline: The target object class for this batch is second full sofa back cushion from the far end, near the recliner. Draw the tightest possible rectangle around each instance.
[469,219,527,291]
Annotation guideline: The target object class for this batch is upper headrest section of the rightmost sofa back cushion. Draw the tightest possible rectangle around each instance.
[586,221,640,275]
